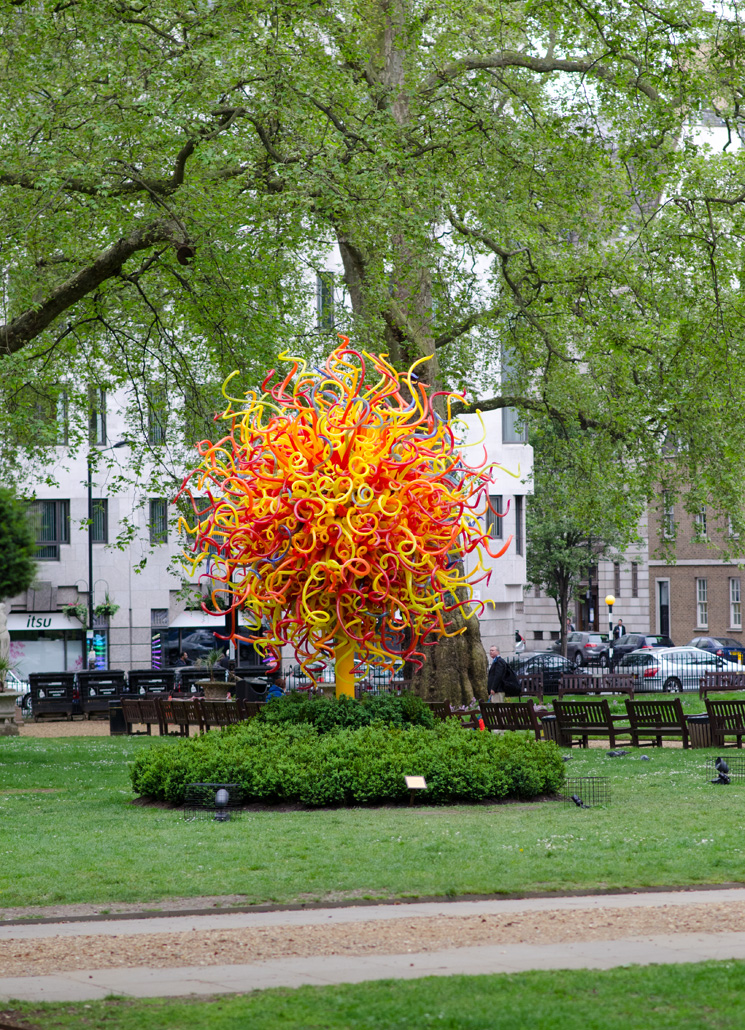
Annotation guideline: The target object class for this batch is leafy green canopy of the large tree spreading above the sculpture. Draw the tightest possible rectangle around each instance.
[0,0,745,696]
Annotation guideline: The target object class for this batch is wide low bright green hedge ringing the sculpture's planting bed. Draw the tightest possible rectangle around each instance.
[131,719,565,806]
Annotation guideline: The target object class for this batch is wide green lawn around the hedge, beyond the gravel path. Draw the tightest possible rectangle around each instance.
[0,737,745,908]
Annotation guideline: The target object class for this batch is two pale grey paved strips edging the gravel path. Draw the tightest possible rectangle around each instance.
[0,888,745,1002]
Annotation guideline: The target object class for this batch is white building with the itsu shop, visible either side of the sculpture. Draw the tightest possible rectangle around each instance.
[7,370,532,679]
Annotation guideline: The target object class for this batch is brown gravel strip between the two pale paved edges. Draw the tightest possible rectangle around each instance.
[0,892,745,976]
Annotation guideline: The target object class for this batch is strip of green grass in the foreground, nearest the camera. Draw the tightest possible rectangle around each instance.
[2,962,745,1030]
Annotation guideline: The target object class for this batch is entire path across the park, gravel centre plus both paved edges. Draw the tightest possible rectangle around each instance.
[0,888,745,1002]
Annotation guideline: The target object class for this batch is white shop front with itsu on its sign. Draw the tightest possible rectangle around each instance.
[8,612,86,680]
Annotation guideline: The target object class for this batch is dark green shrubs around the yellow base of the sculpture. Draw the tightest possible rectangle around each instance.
[259,691,435,733]
